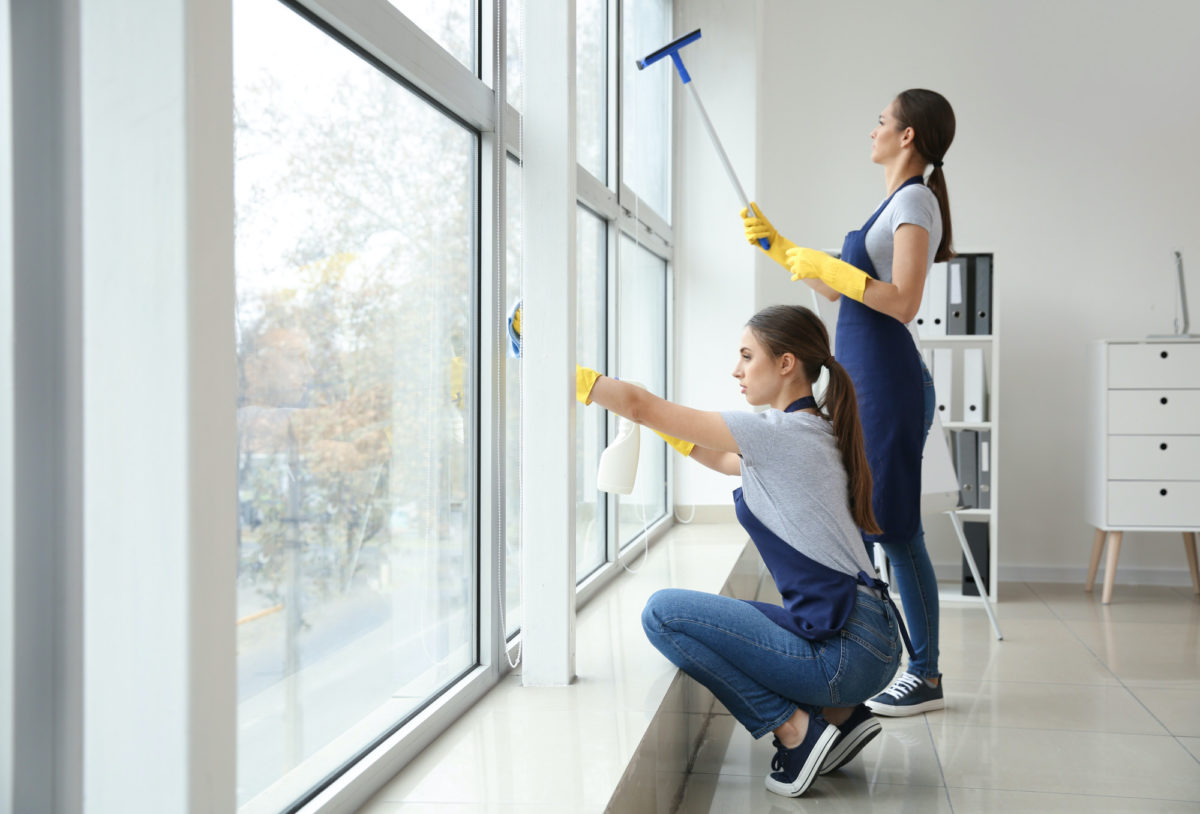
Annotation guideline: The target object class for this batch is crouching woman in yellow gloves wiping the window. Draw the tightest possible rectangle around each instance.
[576,305,904,797]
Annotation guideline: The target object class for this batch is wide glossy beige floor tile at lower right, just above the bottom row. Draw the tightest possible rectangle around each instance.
[932,725,1200,801]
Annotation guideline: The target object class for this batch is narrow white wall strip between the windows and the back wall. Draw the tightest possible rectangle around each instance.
[676,0,758,509]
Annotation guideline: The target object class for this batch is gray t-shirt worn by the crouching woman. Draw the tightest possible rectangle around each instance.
[721,409,875,576]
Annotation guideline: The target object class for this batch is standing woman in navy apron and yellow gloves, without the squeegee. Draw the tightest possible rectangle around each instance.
[742,89,954,716]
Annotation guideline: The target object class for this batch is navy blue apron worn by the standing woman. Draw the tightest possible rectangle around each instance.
[835,175,925,544]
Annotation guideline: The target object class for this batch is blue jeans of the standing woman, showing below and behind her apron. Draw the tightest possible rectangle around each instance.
[880,364,941,678]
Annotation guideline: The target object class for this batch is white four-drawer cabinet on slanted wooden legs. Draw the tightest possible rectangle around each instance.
[1085,339,1200,603]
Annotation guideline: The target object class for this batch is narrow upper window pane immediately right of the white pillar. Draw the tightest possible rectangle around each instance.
[575,0,608,184]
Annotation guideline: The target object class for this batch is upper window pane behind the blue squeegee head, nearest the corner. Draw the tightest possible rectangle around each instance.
[620,0,672,220]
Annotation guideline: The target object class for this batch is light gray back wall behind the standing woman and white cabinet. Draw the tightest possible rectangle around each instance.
[677,0,1200,581]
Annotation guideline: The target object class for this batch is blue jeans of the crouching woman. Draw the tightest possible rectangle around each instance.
[642,588,901,737]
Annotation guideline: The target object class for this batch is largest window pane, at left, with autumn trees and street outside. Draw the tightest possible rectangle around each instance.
[234,0,479,810]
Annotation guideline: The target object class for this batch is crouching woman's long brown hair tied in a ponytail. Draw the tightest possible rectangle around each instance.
[746,305,881,534]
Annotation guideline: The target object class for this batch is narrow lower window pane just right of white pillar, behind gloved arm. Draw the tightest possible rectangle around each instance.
[575,207,608,581]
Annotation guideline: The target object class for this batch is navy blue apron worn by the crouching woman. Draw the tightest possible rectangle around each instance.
[733,396,913,657]
